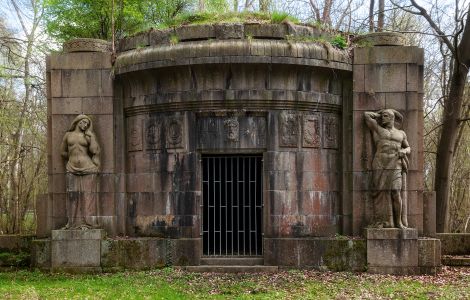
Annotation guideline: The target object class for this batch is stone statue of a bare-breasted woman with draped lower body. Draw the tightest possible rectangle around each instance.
[60,115,100,229]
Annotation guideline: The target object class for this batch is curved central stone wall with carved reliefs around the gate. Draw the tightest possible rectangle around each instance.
[116,35,351,246]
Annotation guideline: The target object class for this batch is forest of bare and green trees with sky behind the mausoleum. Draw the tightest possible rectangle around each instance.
[0,0,470,234]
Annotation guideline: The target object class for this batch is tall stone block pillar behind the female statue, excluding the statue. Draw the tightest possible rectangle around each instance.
[43,39,119,236]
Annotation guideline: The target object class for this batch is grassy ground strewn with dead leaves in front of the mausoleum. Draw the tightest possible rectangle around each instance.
[0,268,470,299]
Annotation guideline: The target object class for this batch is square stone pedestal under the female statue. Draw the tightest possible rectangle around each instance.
[51,229,106,273]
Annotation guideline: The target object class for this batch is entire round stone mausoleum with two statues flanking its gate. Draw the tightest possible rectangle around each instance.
[35,24,440,274]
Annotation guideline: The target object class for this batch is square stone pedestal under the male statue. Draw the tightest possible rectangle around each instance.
[366,228,420,275]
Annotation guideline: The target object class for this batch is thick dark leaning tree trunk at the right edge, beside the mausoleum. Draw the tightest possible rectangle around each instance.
[434,10,470,232]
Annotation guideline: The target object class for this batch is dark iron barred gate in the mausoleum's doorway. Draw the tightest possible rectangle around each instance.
[202,156,263,256]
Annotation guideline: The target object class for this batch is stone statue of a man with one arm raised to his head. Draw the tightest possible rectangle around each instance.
[364,109,411,228]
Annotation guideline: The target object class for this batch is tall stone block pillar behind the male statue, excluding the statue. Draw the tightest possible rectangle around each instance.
[350,41,424,235]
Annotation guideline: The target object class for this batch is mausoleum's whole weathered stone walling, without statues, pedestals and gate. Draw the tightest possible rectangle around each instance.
[37,24,433,269]
